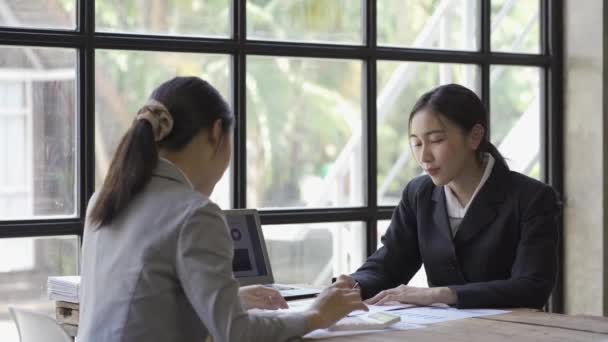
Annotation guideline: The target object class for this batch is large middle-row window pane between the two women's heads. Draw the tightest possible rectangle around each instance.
[247,57,365,207]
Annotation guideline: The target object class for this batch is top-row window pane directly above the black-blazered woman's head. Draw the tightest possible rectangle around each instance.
[377,0,479,50]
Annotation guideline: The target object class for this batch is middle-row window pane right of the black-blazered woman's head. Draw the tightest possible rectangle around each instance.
[490,65,542,179]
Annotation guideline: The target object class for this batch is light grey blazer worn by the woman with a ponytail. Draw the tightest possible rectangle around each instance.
[77,160,306,342]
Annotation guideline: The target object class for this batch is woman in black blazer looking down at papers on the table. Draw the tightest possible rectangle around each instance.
[334,84,560,308]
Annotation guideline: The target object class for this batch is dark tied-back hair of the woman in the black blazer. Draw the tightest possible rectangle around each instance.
[409,84,508,168]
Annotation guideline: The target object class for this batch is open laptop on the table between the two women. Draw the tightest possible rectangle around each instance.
[224,209,321,300]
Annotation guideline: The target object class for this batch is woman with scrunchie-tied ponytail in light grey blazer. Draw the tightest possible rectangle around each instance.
[77,77,366,342]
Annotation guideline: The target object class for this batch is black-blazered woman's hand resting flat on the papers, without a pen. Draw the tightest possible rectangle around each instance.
[365,285,458,305]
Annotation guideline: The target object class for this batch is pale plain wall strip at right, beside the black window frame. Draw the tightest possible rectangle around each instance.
[564,0,608,315]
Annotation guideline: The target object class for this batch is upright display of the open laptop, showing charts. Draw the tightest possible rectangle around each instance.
[226,213,269,278]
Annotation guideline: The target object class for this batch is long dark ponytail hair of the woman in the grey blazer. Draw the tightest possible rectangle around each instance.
[89,77,234,226]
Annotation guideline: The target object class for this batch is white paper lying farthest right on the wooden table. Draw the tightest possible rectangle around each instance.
[391,306,509,324]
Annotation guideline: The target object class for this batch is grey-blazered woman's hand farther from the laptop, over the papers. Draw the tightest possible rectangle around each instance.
[307,287,369,331]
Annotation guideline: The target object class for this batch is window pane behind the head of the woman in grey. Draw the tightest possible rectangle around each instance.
[95,50,230,208]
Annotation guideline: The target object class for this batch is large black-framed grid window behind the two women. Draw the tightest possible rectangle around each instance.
[0,0,563,334]
